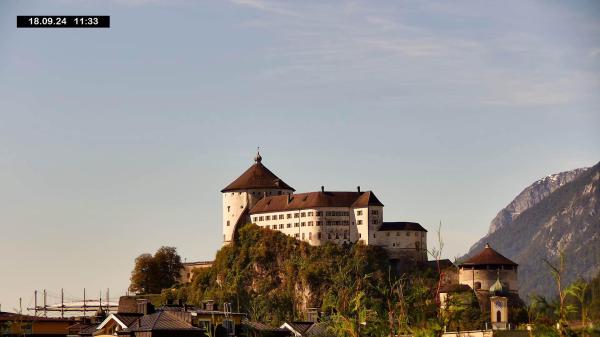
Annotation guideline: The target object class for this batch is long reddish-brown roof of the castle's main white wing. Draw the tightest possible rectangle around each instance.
[250,191,383,214]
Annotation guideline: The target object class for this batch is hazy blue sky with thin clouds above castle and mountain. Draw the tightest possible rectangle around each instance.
[0,0,600,310]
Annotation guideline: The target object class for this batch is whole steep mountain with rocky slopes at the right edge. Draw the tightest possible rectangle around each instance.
[465,163,600,299]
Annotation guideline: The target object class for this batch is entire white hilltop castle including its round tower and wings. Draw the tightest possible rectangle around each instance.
[221,153,427,261]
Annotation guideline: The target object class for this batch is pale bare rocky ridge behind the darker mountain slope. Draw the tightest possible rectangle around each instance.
[488,167,589,234]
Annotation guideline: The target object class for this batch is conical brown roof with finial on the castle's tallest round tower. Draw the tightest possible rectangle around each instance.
[221,154,295,192]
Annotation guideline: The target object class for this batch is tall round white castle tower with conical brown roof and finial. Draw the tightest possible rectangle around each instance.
[221,152,295,245]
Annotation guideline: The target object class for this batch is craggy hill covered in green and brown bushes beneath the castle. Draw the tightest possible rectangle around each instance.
[183,224,390,323]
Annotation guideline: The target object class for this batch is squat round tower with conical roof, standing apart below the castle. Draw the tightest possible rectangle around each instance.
[458,244,519,293]
